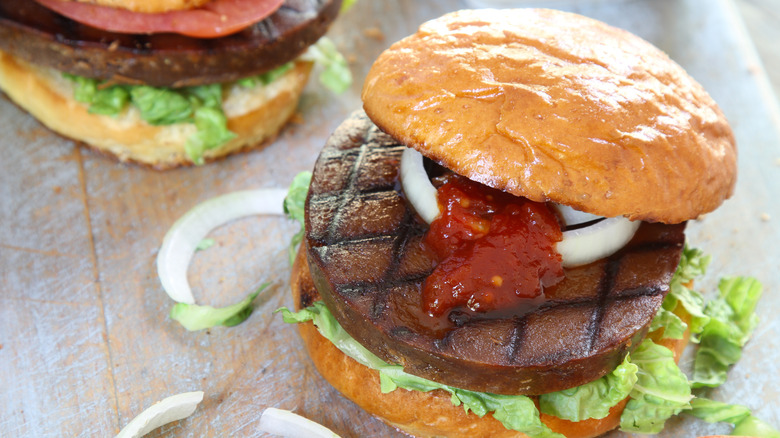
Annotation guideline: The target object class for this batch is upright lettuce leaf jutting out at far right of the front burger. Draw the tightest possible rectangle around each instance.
[693,277,762,388]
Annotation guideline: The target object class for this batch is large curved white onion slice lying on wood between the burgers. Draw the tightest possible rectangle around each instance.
[157,189,287,304]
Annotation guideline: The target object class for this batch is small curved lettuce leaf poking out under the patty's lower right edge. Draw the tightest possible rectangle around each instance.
[539,356,638,421]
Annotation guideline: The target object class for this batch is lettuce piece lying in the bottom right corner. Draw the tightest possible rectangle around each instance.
[687,397,780,438]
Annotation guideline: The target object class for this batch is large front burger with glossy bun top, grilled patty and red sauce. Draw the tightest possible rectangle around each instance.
[282,9,768,438]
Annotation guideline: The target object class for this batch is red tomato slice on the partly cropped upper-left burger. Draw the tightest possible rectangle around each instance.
[36,0,284,38]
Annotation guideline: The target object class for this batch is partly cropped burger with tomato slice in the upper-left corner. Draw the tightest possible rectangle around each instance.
[0,0,348,169]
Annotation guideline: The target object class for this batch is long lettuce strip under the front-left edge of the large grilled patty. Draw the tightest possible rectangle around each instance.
[277,301,564,438]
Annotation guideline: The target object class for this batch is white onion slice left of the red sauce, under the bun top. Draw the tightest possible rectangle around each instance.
[401,148,439,224]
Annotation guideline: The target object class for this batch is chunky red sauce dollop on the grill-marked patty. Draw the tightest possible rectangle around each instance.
[422,174,563,317]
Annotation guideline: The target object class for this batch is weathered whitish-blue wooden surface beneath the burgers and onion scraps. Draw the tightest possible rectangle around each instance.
[0,0,780,437]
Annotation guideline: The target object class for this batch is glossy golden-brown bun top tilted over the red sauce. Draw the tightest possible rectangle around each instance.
[363,9,736,223]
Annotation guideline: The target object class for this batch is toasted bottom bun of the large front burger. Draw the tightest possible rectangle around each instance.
[291,251,688,438]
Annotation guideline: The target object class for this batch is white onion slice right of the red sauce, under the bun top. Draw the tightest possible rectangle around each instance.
[557,216,641,268]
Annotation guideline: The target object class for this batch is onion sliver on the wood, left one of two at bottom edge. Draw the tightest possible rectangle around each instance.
[116,391,203,438]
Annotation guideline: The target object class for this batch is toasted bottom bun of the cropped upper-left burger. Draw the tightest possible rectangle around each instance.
[0,52,312,169]
